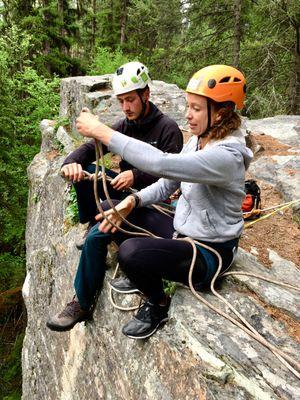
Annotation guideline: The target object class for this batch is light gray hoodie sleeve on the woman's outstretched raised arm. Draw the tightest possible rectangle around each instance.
[109,132,250,186]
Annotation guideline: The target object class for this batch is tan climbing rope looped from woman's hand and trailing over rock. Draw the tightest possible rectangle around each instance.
[82,135,300,378]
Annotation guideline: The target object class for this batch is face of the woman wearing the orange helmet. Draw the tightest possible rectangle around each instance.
[186,93,215,136]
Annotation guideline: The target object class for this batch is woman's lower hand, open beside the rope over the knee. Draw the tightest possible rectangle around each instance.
[95,195,135,233]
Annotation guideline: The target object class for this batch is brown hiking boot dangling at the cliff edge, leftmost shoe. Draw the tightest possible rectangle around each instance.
[46,297,91,332]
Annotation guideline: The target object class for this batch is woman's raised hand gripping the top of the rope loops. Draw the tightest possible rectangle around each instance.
[76,107,113,146]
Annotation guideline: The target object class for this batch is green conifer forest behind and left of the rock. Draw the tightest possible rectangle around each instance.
[0,0,300,400]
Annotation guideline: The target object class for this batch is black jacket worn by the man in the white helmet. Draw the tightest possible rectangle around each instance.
[62,102,183,190]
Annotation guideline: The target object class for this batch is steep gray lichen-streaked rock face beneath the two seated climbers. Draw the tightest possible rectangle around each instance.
[22,77,300,400]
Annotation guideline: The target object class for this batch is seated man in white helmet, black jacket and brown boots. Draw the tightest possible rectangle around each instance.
[47,62,183,331]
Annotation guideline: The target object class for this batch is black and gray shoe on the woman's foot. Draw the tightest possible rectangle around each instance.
[122,299,170,339]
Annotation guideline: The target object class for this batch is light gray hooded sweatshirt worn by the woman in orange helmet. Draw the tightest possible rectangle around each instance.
[109,130,253,243]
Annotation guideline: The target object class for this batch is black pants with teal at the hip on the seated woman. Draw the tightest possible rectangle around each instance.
[119,208,238,303]
